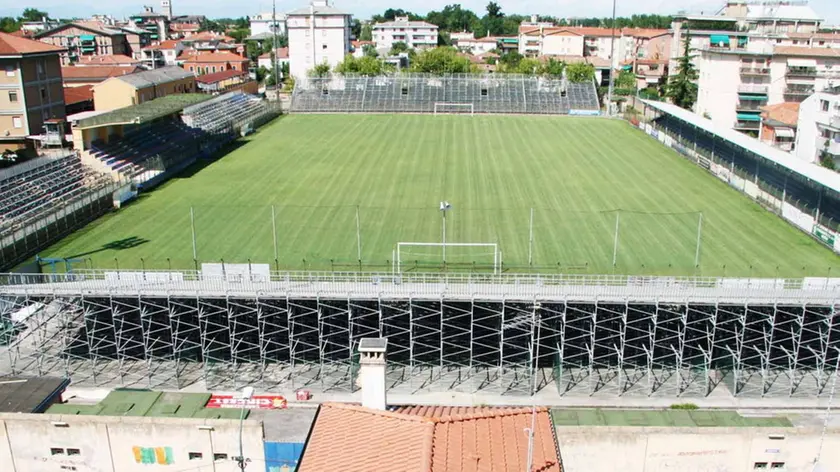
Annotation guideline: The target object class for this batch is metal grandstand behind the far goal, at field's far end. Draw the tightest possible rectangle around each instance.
[291,74,600,114]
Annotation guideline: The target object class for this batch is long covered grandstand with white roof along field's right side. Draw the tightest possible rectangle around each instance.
[639,101,840,253]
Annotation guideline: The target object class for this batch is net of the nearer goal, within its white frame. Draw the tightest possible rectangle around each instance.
[394,242,502,274]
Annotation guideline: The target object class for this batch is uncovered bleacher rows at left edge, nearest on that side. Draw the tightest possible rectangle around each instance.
[0,154,111,230]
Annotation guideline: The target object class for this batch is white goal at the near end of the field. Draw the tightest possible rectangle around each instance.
[393,242,502,274]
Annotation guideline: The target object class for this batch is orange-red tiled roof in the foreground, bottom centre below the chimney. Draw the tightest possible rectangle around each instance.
[298,403,560,472]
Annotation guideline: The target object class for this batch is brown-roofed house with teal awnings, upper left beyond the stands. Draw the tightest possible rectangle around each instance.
[35,22,131,65]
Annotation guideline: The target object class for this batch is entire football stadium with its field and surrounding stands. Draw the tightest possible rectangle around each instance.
[0,75,840,398]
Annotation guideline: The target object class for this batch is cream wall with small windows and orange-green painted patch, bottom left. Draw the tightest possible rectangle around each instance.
[0,413,265,472]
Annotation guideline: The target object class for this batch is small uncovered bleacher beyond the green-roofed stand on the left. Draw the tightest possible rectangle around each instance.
[183,92,268,132]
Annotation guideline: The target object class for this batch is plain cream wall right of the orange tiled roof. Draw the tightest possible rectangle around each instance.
[557,426,840,472]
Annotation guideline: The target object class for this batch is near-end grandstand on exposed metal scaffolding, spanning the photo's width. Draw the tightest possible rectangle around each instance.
[0,271,840,398]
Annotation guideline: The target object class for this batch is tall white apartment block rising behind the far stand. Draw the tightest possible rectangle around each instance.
[286,0,351,77]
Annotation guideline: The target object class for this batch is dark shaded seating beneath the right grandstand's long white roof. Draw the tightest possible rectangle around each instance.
[654,115,840,224]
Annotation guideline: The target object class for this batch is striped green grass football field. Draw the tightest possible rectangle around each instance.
[41,115,840,277]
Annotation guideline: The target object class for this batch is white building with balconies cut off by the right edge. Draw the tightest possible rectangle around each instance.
[796,86,840,167]
